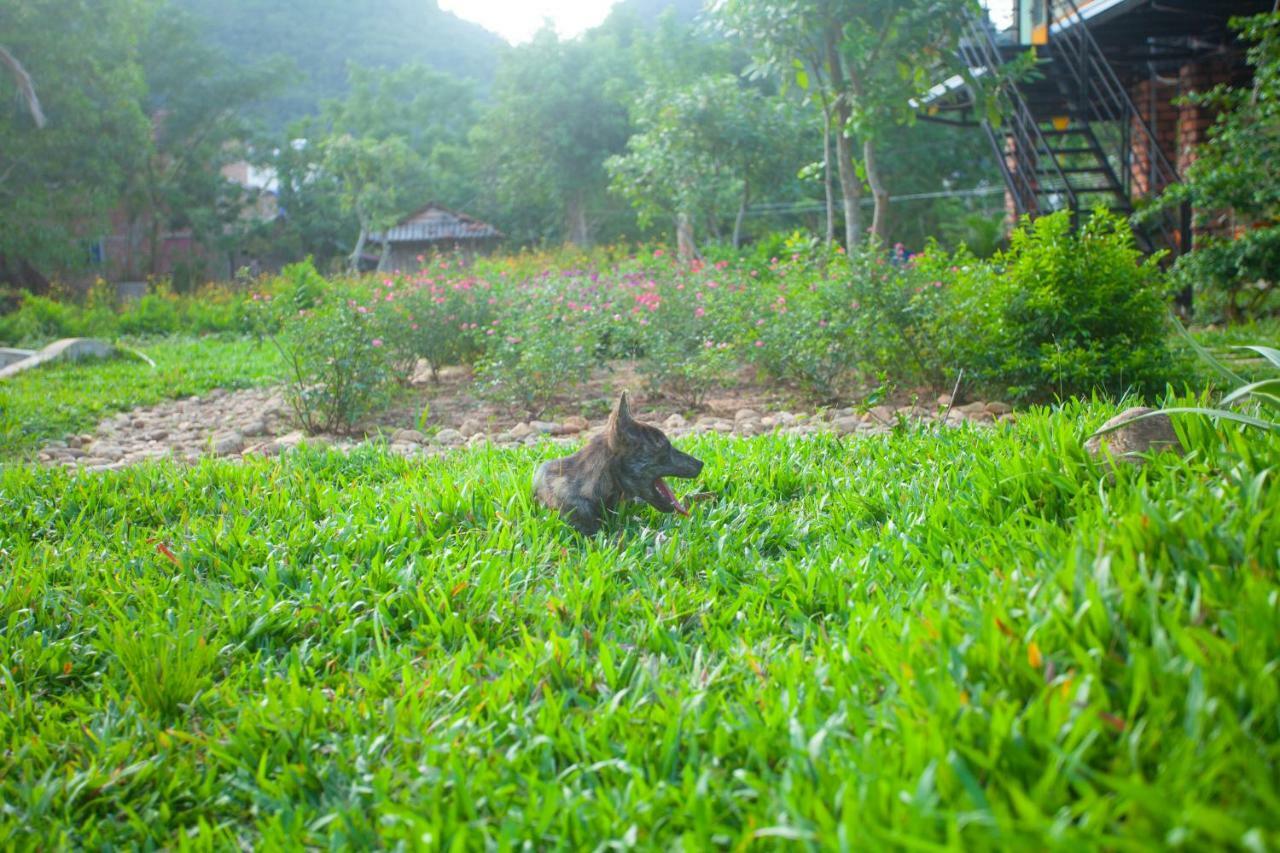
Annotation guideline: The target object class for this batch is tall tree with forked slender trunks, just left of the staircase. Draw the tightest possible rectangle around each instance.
[714,0,975,246]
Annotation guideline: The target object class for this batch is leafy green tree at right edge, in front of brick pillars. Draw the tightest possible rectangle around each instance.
[1144,12,1280,320]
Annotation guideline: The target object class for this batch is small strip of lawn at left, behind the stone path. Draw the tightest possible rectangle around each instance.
[0,336,280,460]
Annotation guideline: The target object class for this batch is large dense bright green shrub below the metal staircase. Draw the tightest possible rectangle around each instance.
[933,209,1172,401]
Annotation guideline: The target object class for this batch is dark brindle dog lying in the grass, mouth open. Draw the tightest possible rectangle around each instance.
[534,391,703,535]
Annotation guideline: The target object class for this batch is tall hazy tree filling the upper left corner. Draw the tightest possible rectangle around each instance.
[0,0,147,289]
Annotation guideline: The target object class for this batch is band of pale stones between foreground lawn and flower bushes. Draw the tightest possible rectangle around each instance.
[38,388,1012,470]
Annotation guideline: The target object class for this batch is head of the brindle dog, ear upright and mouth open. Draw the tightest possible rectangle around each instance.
[605,391,703,515]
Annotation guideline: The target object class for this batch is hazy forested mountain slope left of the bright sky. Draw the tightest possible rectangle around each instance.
[174,0,506,127]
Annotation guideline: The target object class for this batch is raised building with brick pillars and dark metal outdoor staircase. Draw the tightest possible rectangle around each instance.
[919,0,1274,272]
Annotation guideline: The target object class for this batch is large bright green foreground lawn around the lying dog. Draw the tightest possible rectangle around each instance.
[0,405,1280,850]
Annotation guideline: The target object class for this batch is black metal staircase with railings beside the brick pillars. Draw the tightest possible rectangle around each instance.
[960,0,1190,255]
